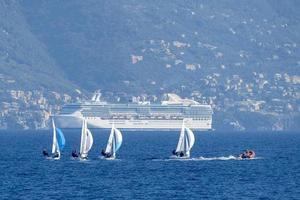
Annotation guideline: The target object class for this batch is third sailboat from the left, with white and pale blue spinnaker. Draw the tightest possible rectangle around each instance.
[101,125,123,160]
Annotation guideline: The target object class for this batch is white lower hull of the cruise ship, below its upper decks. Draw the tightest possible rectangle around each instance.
[55,115,212,131]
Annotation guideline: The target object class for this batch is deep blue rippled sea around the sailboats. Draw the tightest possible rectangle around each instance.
[0,129,300,200]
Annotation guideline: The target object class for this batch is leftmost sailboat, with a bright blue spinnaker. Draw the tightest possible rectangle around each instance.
[52,119,66,160]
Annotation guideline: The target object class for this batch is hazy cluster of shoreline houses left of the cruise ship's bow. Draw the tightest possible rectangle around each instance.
[0,90,72,129]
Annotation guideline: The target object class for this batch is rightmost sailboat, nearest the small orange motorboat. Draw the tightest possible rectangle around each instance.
[173,123,195,158]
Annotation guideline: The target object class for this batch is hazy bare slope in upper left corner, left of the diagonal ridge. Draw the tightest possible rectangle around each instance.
[0,1,78,91]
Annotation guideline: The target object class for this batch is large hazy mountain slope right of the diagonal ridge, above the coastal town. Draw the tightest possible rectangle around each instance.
[22,0,300,94]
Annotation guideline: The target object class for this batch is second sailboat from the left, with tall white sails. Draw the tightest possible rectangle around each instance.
[80,119,94,159]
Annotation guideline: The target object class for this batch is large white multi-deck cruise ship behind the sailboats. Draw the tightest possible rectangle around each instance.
[54,92,213,131]
